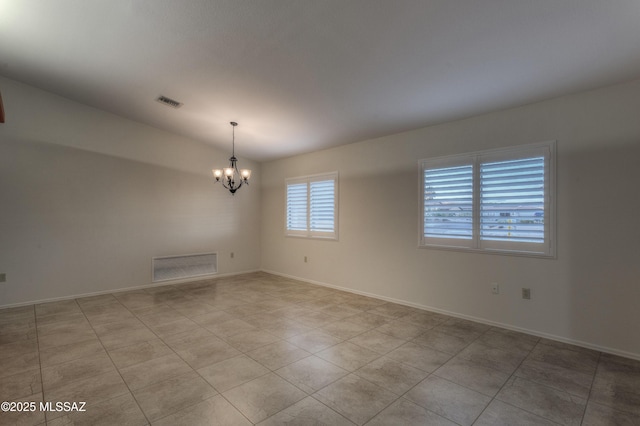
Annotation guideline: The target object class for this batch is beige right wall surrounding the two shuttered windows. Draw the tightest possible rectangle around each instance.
[262,81,640,358]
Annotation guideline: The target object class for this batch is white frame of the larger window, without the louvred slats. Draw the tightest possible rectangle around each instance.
[418,141,557,258]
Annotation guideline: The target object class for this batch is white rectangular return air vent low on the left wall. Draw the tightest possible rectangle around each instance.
[151,253,218,283]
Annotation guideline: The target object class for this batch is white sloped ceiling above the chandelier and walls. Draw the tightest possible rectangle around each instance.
[0,0,640,161]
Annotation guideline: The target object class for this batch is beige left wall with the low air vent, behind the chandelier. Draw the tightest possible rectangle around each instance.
[0,78,260,306]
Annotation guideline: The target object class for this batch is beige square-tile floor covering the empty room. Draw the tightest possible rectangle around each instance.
[0,273,640,426]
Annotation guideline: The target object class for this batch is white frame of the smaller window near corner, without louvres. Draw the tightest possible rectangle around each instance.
[284,171,339,241]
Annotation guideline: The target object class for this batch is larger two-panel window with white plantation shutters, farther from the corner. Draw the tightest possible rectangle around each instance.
[420,142,555,257]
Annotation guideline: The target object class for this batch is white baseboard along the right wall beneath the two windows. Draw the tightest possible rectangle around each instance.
[262,269,640,361]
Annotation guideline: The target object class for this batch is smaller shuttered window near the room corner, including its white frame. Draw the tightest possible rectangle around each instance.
[285,172,338,239]
